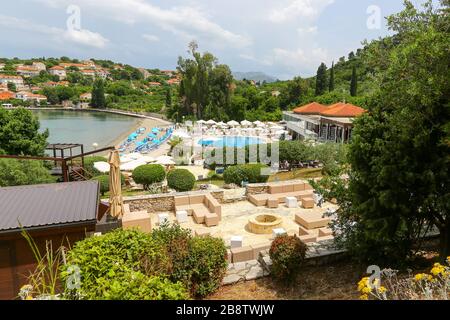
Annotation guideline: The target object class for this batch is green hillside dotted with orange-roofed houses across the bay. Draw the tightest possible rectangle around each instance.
[0,57,180,112]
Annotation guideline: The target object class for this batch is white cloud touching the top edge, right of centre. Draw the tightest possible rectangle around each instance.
[269,0,334,23]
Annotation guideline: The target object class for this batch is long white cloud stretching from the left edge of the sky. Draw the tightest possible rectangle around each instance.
[0,15,108,48]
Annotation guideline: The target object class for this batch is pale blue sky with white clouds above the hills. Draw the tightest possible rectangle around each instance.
[0,0,432,79]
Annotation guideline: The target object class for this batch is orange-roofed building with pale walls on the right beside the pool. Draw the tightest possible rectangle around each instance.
[283,102,366,143]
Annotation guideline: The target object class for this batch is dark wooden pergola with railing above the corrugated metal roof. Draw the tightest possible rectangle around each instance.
[0,143,115,182]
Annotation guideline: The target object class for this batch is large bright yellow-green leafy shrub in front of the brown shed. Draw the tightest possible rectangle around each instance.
[61,230,170,299]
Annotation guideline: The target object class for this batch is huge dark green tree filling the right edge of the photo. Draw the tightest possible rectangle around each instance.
[318,1,450,263]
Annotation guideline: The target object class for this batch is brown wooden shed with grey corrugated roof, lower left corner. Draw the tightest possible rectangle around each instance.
[0,181,107,300]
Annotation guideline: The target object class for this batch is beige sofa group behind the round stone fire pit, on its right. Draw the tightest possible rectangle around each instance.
[248,181,314,209]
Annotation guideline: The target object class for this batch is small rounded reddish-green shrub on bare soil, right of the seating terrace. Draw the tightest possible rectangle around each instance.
[269,235,307,282]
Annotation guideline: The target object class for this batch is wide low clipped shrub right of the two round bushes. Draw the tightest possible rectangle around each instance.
[223,163,269,186]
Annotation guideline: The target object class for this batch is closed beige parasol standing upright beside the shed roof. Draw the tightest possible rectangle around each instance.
[108,150,124,217]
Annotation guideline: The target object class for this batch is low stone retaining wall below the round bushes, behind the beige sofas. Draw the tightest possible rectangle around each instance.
[123,190,224,212]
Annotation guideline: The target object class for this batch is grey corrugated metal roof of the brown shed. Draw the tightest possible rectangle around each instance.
[0,181,99,231]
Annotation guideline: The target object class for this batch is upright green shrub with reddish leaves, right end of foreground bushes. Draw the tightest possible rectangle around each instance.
[189,237,227,297]
